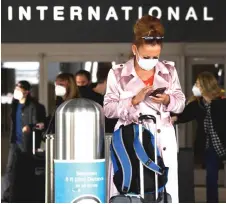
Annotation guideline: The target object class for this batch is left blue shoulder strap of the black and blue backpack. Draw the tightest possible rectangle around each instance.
[112,128,132,193]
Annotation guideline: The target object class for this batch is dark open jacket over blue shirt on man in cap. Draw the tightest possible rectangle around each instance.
[10,96,46,152]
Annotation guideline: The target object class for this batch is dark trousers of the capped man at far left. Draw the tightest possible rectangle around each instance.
[2,143,22,202]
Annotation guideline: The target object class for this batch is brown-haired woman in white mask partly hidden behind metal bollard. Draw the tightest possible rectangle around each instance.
[45,73,79,134]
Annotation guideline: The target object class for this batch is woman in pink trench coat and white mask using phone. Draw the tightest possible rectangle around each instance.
[104,15,185,203]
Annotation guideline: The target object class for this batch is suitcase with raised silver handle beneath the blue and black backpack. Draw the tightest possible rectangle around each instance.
[109,114,171,203]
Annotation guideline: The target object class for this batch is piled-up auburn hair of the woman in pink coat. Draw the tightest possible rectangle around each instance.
[133,15,164,47]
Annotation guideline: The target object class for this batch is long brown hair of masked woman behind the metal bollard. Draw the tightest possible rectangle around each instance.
[56,73,79,101]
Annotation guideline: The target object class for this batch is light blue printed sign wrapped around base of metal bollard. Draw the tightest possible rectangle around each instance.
[54,159,106,203]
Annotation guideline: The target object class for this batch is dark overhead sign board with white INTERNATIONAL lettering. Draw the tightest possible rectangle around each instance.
[2,0,226,43]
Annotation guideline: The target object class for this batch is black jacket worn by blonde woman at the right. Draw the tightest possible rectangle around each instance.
[177,98,226,159]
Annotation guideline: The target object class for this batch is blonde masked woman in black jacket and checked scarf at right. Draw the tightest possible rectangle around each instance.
[172,72,226,203]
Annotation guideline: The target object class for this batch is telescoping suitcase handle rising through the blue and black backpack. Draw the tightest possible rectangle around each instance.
[138,113,158,200]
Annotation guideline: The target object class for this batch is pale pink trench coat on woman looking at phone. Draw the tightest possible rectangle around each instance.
[104,60,185,203]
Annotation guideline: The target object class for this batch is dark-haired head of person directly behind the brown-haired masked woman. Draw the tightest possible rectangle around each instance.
[75,70,91,87]
